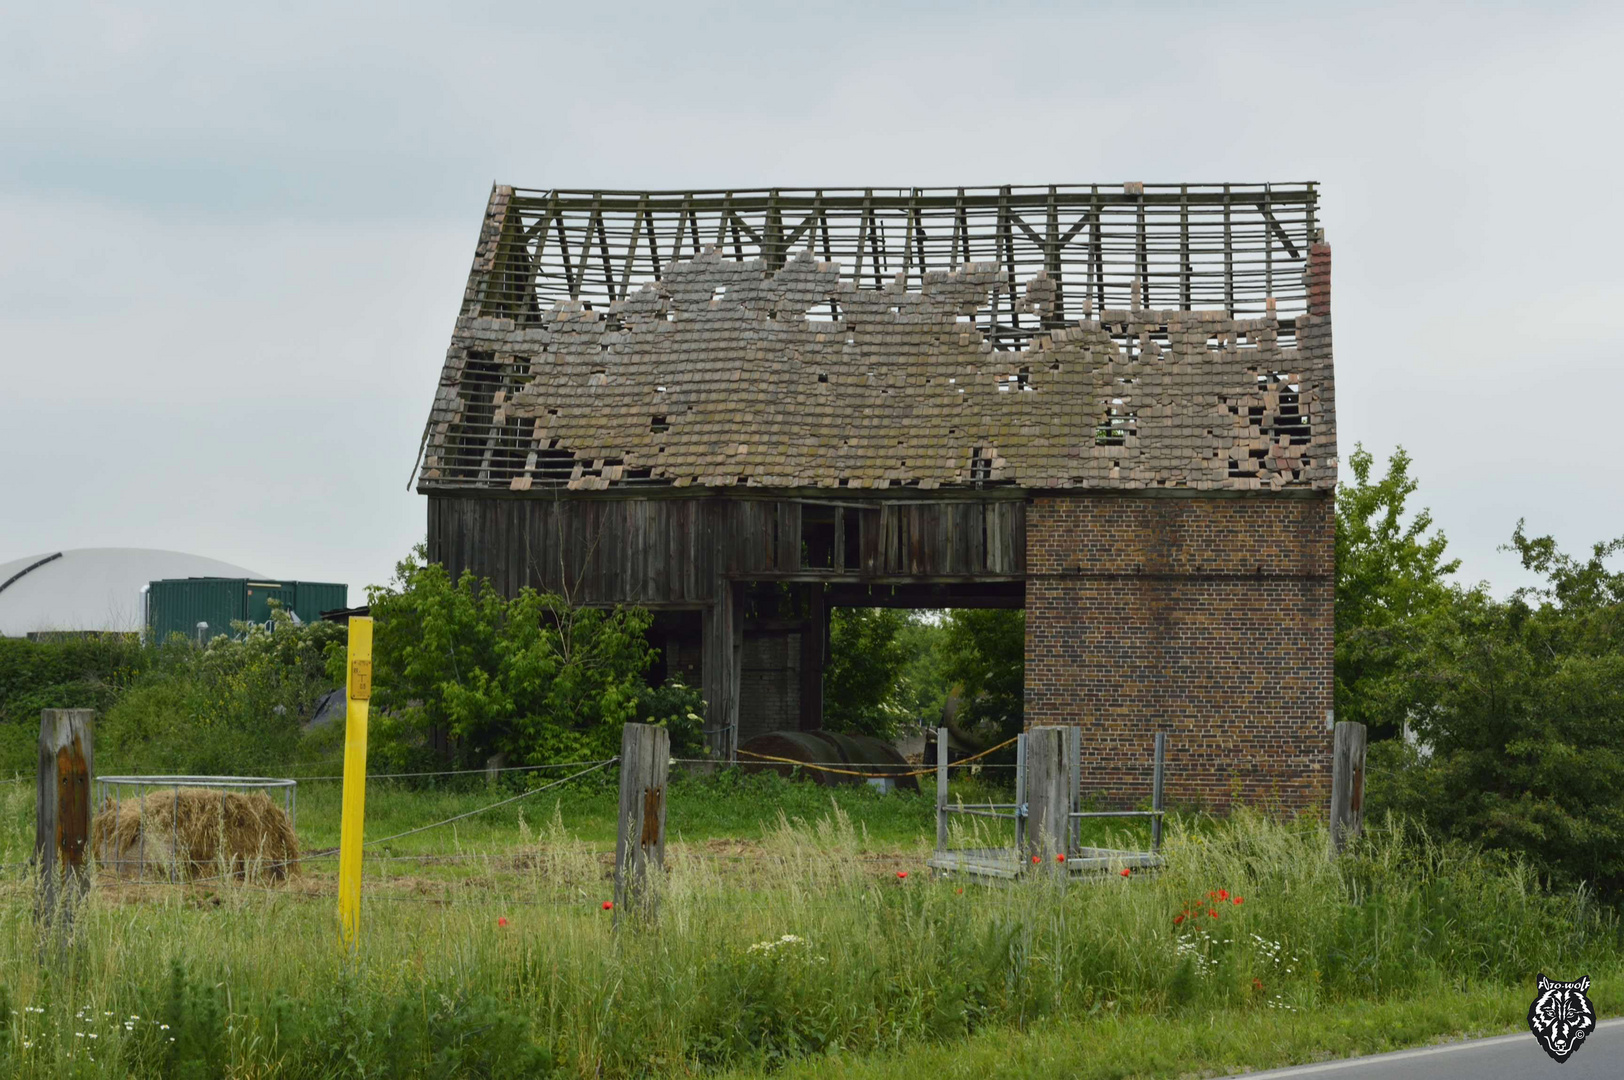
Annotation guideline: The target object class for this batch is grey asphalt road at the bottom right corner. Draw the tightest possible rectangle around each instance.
[1246,1018,1624,1080]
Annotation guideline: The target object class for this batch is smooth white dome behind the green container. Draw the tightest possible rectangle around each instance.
[0,547,261,637]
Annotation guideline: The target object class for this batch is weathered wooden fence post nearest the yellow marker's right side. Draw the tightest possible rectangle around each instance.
[614,724,671,926]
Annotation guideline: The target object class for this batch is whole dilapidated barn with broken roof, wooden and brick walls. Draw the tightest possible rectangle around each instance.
[417,184,1337,807]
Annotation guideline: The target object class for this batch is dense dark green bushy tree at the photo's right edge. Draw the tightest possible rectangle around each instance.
[1372,523,1624,898]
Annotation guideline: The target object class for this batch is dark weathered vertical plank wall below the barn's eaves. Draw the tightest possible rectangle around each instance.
[429,495,1026,606]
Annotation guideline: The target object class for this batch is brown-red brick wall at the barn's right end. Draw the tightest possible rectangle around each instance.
[1026,494,1335,810]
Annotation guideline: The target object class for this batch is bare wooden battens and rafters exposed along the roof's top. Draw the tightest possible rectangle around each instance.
[481,182,1319,331]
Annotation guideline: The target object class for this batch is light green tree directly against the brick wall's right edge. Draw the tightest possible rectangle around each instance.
[1335,445,1460,739]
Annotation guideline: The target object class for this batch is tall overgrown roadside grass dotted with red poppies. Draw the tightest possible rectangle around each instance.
[0,784,1621,1077]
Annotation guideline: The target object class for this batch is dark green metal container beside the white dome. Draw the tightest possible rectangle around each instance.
[146,578,349,642]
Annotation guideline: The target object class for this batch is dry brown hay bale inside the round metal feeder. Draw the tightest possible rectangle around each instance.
[91,788,299,882]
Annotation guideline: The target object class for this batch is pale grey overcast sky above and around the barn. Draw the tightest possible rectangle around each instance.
[0,0,1624,603]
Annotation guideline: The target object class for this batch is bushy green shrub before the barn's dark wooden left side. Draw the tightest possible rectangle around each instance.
[367,547,651,768]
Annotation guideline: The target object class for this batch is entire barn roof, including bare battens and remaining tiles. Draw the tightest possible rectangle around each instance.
[419,184,1335,499]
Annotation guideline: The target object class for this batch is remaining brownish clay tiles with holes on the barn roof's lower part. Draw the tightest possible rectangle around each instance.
[419,195,1337,492]
